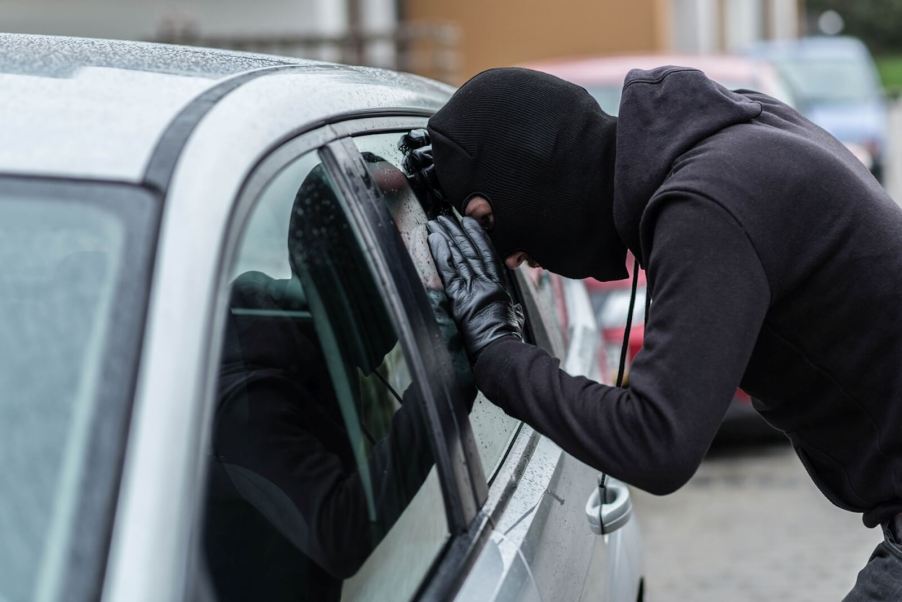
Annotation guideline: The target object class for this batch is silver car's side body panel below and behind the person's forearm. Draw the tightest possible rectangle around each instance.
[457,270,643,601]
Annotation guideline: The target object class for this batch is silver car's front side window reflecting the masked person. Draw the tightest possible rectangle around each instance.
[203,153,449,600]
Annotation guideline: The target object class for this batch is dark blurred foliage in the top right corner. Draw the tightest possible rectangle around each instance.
[806,0,902,54]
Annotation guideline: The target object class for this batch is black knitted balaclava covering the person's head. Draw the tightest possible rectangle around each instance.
[427,68,628,280]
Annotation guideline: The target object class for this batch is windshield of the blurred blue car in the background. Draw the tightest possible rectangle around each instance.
[776,56,879,102]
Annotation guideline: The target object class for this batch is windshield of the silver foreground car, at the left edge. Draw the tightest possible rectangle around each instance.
[0,180,152,600]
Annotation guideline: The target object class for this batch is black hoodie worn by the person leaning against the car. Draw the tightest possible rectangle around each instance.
[475,67,902,526]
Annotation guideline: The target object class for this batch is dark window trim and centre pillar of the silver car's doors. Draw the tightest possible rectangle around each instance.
[189,110,644,599]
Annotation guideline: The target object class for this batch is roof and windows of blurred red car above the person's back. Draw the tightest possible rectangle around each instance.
[526,54,796,115]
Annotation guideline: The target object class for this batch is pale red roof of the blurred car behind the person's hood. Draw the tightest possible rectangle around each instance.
[526,54,770,85]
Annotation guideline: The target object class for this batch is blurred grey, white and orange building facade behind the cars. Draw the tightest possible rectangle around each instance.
[0,0,804,83]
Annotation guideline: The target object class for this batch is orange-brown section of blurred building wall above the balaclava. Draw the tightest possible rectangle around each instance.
[402,0,670,83]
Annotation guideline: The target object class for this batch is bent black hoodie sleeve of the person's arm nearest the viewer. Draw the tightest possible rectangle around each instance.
[475,195,770,494]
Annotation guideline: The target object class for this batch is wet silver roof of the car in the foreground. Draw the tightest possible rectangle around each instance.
[0,34,449,181]
